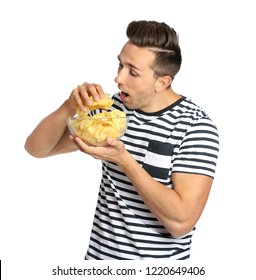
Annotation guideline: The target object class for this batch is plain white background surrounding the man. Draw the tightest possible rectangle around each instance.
[0,0,256,280]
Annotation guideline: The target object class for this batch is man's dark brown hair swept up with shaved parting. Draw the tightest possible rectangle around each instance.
[126,20,182,79]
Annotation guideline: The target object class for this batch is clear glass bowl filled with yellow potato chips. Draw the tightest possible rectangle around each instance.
[67,109,127,146]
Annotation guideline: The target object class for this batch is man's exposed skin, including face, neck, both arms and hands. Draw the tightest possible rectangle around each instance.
[25,41,213,238]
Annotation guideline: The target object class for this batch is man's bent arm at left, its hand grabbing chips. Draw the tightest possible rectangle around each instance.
[25,83,104,158]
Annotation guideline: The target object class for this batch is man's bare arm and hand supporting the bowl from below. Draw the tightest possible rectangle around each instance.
[73,137,213,237]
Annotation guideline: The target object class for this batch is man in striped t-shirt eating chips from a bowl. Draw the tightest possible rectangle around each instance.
[25,21,219,260]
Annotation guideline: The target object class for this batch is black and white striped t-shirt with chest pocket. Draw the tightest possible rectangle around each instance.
[85,94,219,260]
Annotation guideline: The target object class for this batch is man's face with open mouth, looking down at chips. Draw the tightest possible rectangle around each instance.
[115,41,160,112]
